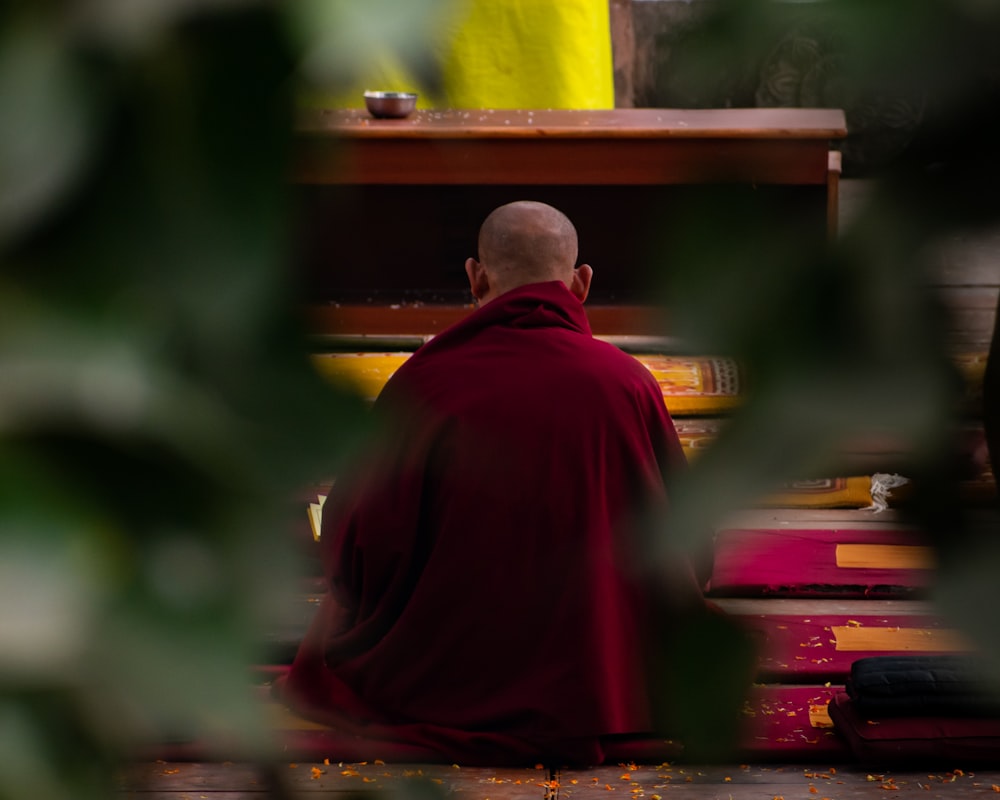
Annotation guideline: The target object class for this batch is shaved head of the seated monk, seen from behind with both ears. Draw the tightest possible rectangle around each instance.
[467,200,590,300]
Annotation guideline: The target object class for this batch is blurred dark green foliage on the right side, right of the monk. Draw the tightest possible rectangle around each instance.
[640,0,1000,756]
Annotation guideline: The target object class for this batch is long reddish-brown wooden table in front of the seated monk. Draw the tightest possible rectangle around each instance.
[292,109,846,344]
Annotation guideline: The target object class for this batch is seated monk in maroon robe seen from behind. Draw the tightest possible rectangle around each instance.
[280,202,700,764]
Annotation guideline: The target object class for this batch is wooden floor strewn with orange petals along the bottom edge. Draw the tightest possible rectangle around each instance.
[118,762,1000,800]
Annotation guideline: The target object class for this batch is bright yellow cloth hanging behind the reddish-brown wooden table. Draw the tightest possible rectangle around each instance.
[304,0,615,109]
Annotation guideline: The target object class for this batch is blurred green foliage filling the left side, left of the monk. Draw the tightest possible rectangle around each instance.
[0,0,454,800]
